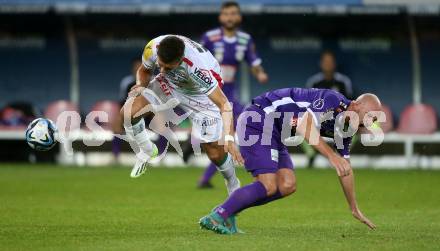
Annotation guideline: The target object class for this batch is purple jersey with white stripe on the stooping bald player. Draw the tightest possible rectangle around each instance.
[252,88,351,158]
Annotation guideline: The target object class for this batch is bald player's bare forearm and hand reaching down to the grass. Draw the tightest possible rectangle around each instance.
[339,172,376,229]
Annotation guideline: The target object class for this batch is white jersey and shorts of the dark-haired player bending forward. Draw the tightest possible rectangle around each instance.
[142,35,223,142]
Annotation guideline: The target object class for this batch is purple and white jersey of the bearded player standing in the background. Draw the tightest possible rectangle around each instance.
[200,28,261,100]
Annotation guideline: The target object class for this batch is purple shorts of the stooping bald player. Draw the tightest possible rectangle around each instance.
[237,105,293,177]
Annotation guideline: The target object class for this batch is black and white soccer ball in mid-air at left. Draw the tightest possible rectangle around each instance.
[26,118,58,151]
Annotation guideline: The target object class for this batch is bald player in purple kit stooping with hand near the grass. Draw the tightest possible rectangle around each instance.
[200,88,381,234]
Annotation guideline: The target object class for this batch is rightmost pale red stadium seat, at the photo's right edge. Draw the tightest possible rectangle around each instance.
[397,104,437,134]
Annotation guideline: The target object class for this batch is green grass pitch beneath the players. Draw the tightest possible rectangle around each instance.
[0,164,440,250]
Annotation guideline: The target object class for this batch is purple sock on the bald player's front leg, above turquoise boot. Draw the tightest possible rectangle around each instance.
[216,181,267,220]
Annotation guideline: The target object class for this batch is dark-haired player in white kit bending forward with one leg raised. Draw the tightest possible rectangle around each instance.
[121,35,243,194]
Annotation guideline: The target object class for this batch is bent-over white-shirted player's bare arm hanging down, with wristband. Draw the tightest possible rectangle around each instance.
[209,86,244,165]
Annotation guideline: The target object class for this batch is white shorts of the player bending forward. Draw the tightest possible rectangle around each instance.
[142,80,223,143]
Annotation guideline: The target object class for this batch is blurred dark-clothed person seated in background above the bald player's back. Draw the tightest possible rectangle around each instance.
[306,51,353,99]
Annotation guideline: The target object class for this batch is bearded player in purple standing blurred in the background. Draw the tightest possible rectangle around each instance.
[198,1,268,188]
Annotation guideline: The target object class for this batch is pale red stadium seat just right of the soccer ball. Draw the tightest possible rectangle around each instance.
[44,100,81,130]
